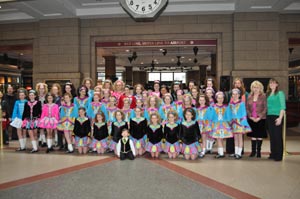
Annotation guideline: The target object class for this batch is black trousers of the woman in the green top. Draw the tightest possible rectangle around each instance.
[267,115,283,160]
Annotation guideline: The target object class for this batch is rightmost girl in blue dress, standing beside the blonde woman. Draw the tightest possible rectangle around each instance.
[229,88,251,159]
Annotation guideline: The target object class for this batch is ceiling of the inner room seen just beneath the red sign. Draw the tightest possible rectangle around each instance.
[97,46,216,71]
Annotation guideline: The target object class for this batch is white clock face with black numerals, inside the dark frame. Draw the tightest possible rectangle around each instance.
[126,0,162,15]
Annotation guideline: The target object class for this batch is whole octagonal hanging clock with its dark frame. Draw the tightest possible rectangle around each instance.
[119,0,168,21]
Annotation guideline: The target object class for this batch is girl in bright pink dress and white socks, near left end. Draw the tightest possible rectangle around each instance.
[39,93,59,153]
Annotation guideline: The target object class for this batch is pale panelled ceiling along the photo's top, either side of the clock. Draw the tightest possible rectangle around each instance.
[0,0,300,23]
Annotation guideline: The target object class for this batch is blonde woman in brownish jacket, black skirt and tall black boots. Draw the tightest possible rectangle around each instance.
[246,81,267,158]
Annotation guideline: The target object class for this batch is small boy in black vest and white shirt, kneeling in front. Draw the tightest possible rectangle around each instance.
[117,129,135,160]
